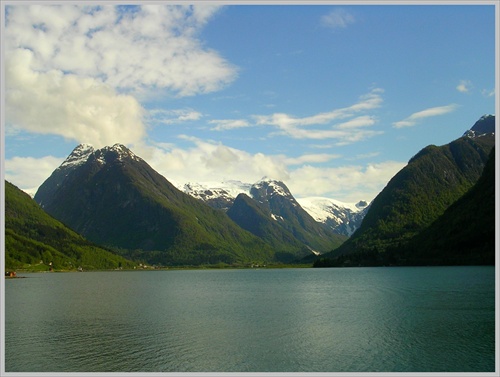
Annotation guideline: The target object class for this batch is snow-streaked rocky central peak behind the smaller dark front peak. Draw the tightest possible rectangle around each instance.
[250,178,346,254]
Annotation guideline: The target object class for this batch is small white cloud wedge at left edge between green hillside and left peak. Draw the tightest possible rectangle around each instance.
[5,156,64,196]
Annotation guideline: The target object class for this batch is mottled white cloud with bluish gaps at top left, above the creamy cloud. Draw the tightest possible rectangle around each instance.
[4,4,237,96]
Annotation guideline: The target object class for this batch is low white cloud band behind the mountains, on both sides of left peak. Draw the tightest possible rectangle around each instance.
[5,136,405,202]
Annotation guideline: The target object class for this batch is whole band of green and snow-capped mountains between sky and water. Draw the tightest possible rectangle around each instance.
[6,116,495,270]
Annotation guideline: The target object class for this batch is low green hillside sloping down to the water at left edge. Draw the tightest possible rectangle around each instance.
[5,181,135,270]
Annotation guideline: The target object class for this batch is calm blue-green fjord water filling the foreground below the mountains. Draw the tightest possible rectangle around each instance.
[5,267,495,372]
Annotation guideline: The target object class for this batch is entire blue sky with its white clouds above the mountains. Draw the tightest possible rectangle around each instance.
[2,1,498,203]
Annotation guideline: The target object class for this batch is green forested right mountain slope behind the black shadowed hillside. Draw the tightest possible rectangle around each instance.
[318,116,495,264]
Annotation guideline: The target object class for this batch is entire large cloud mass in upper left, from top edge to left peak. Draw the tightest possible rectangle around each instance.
[4,5,237,147]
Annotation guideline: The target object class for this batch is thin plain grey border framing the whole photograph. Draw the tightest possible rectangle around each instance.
[0,0,500,377]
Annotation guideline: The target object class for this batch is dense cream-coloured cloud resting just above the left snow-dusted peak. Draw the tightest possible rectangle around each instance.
[5,49,145,147]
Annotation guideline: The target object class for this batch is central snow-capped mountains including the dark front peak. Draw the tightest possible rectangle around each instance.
[182,177,348,254]
